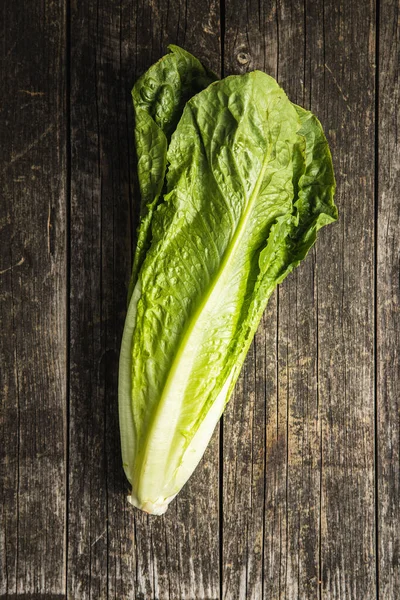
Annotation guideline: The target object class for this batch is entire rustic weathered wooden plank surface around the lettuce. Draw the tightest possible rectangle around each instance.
[0,0,400,600]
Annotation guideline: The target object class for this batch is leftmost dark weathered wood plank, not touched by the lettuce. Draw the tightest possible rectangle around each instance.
[0,2,66,598]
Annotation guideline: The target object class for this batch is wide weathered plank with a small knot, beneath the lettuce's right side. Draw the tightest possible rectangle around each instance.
[223,1,376,598]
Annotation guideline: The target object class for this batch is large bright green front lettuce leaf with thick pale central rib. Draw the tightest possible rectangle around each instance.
[119,65,337,514]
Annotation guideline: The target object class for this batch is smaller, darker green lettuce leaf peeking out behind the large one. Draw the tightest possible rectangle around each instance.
[128,45,217,301]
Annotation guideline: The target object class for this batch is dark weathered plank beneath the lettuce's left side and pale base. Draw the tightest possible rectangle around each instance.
[68,0,220,600]
